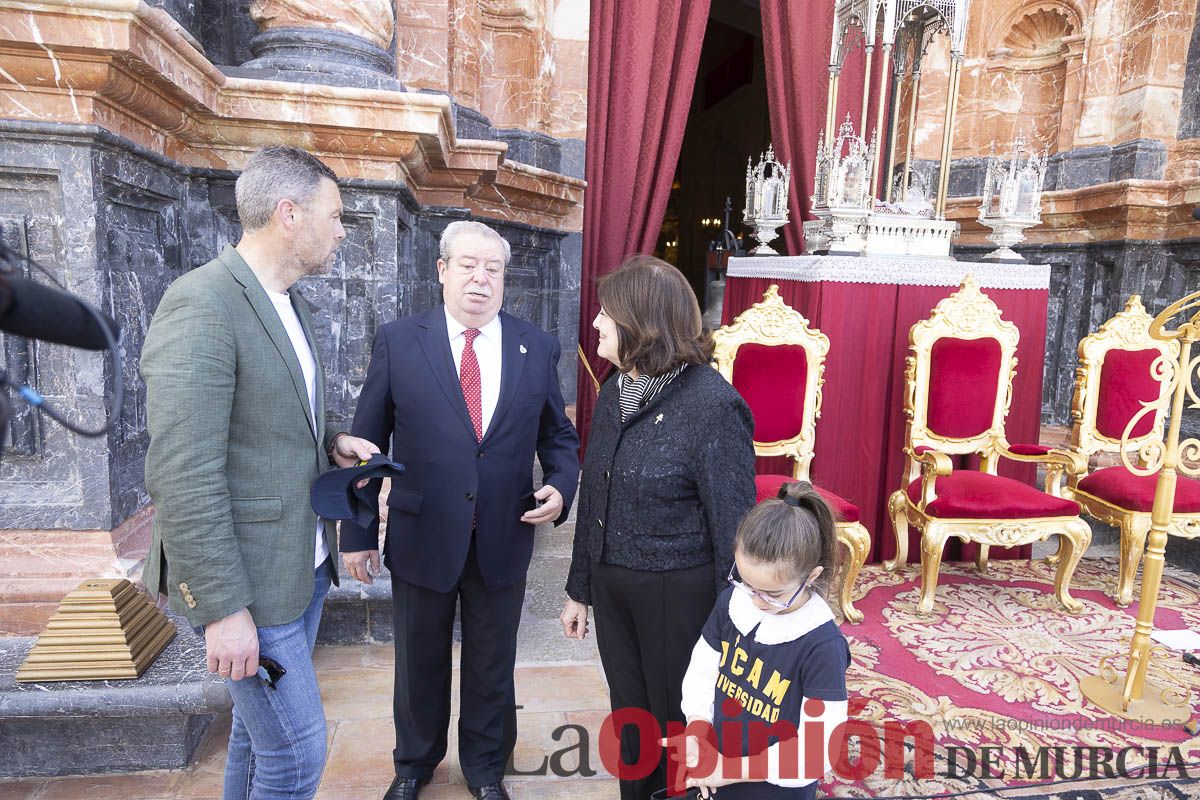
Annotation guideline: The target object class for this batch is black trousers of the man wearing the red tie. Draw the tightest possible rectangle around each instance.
[391,540,526,787]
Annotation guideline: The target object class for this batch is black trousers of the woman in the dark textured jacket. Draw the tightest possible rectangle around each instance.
[592,564,716,800]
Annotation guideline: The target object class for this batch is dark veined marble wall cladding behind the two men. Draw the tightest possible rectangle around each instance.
[0,120,582,530]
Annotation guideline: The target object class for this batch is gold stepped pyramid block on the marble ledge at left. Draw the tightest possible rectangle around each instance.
[16,578,175,682]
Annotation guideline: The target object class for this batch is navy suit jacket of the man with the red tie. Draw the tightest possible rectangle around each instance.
[341,306,580,591]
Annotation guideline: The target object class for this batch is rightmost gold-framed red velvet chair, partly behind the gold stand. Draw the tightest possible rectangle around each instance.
[1069,295,1200,606]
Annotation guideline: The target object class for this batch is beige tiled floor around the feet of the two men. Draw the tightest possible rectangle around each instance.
[0,645,617,800]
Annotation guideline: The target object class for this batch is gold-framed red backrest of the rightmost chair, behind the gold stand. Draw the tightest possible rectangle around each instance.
[1070,295,1180,457]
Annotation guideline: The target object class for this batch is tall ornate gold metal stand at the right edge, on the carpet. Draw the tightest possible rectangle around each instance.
[1079,291,1200,724]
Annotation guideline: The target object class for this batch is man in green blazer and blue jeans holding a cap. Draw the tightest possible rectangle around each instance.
[142,146,378,800]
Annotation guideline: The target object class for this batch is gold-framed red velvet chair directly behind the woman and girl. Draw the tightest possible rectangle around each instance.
[713,284,871,622]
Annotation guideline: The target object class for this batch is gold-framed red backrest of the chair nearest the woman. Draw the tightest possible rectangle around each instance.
[713,284,829,480]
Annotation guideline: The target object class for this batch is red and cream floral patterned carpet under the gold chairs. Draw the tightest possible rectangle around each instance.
[822,559,1200,800]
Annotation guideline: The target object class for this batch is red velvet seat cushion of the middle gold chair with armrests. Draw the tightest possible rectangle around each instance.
[908,470,1079,519]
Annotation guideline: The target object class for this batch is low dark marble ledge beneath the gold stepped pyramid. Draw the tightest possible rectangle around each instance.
[0,616,230,777]
